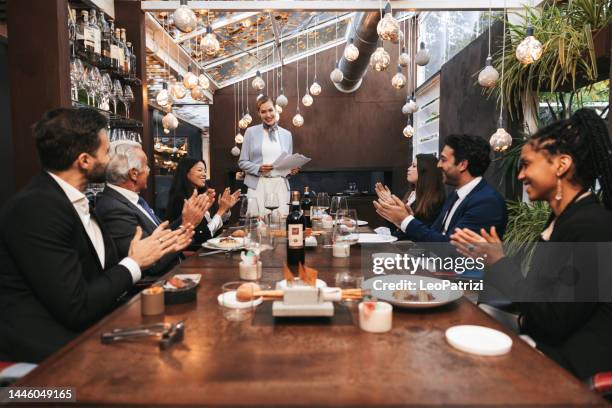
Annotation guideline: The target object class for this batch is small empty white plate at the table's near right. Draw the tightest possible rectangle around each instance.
[446,325,512,356]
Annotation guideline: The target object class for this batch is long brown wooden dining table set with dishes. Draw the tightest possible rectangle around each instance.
[16,228,606,407]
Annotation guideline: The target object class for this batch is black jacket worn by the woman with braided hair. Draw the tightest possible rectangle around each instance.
[485,195,612,379]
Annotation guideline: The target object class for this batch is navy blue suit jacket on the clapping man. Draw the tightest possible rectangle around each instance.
[402,179,508,242]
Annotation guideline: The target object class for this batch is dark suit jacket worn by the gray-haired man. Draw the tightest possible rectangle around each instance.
[96,186,180,276]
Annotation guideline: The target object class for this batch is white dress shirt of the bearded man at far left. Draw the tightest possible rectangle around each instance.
[49,172,142,283]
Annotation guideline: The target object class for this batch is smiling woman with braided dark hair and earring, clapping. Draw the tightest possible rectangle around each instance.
[451,109,612,379]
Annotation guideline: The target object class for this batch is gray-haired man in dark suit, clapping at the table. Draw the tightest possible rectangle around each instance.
[96,141,214,276]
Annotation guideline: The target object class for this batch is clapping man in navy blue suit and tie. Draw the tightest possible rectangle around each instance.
[374,135,507,242]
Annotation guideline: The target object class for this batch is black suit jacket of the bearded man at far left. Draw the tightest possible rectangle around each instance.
[0,173,133,362]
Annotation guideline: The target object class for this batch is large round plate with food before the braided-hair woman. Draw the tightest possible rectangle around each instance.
[363,275,463,309]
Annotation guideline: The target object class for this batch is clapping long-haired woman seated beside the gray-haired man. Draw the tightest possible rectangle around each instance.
[166,157,240,243]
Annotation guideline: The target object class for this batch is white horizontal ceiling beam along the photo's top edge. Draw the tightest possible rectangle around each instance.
[141,0,529,12]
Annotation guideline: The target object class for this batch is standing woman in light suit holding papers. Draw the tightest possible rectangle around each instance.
[238,95,300,216]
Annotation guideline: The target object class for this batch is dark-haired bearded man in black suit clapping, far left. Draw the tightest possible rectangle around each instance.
[0,108,193,363]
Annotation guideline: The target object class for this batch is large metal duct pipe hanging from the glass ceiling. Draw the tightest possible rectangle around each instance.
[334,11,380,93]
